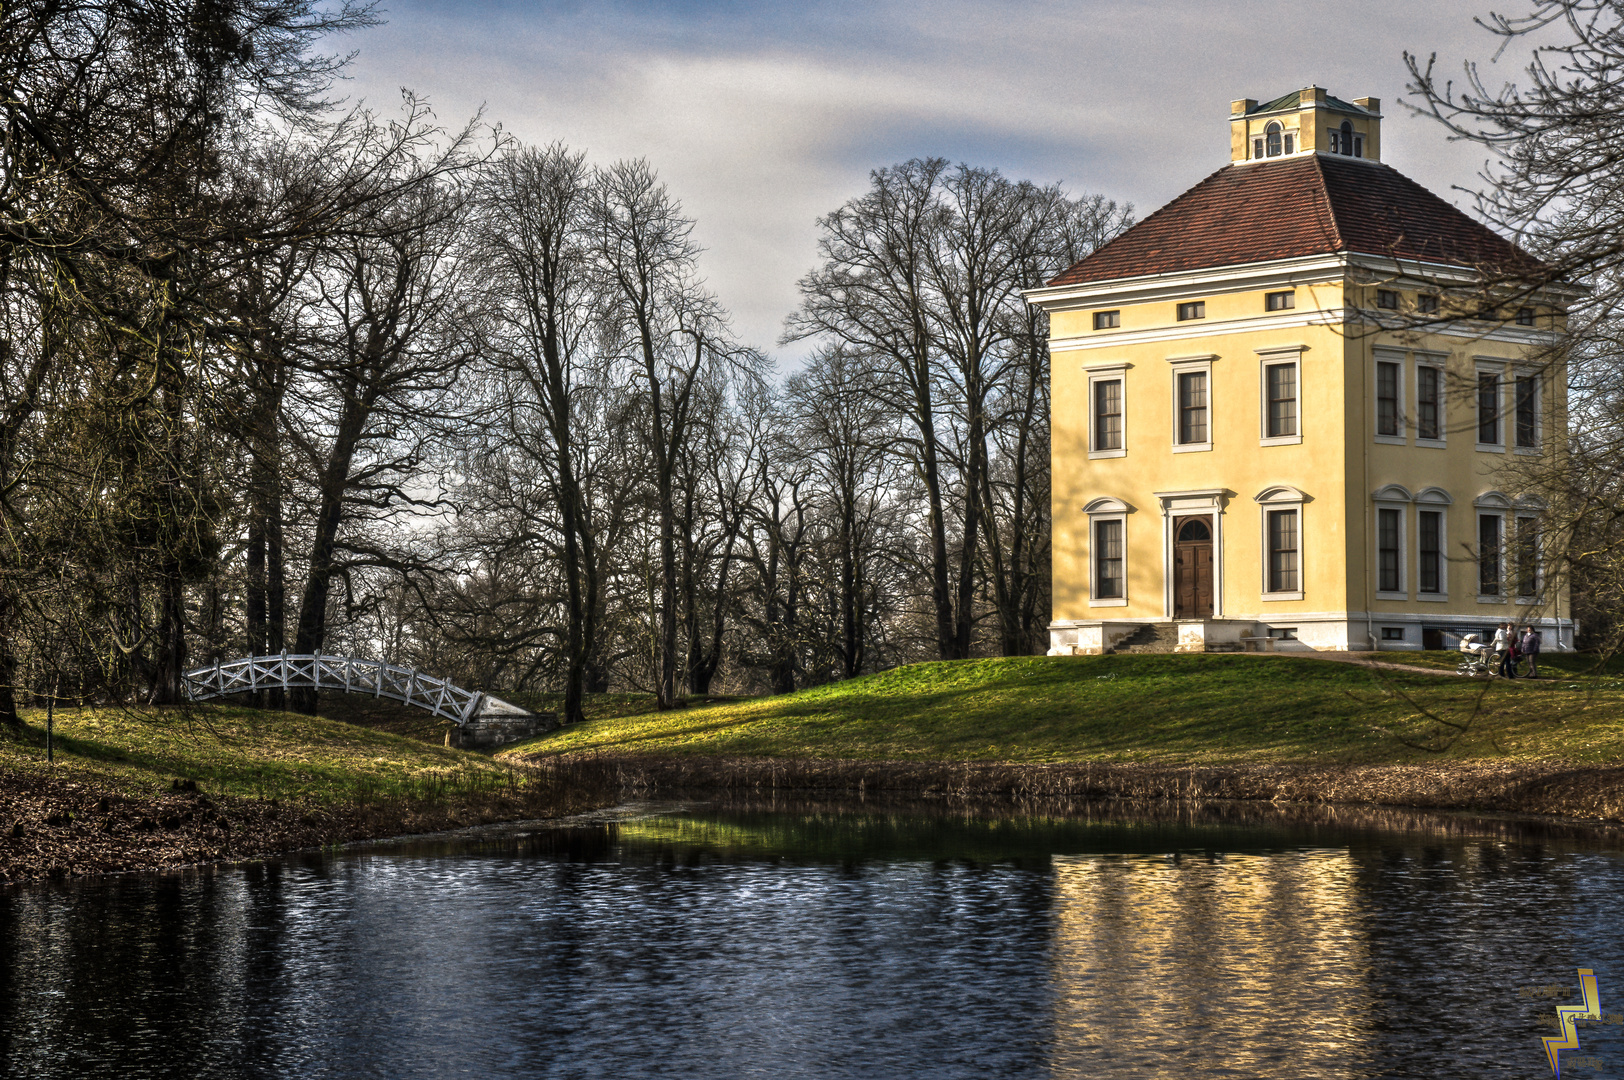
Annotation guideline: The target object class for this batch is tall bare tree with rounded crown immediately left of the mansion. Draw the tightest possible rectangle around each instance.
[784,159,1125,659]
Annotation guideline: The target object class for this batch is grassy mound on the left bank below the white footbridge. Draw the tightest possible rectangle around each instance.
[0,705,526,802]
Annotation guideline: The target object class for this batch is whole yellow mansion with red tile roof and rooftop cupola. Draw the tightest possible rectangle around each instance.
[1028,86,1574,654]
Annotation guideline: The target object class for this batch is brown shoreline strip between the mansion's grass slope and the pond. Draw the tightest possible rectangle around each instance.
[539,754,1624,825]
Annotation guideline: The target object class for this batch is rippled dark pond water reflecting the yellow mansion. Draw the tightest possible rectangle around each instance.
[0,795,1624,1080]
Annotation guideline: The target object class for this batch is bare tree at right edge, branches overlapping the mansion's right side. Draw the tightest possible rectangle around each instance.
[1406,0,1624,650]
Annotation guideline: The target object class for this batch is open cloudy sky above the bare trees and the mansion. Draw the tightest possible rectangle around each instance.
[344,0,1520,365]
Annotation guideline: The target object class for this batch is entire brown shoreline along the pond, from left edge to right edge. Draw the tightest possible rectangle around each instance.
[12,754,1624,890]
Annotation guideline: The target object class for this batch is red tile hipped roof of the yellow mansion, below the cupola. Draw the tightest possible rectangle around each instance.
[1049,154,1535,286]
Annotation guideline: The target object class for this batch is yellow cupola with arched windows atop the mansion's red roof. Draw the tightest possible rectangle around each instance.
[1229,86,1382,162]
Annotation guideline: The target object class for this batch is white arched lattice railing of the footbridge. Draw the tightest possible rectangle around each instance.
[185,653,486,724]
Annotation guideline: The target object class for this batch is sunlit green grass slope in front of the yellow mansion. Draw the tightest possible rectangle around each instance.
[508,654,1624,763]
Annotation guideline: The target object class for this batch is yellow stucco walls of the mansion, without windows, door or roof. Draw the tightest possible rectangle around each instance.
[1051,278,1567,636]
